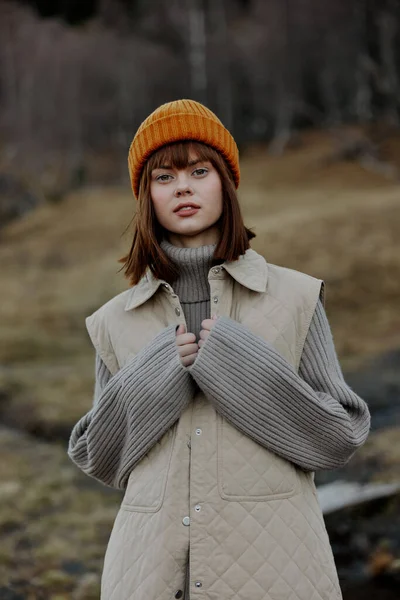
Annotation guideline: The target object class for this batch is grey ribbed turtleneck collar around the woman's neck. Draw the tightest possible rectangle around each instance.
[160,239,216,302]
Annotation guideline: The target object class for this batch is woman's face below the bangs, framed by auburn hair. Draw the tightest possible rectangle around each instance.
[150,151,222,247]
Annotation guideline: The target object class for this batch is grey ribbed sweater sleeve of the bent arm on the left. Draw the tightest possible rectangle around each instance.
[68,325,194,489]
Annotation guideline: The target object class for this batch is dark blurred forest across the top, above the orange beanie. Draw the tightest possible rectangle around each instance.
[0,0,400,188]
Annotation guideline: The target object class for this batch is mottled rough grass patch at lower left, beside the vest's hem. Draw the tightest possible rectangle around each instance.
[0,429,121,600]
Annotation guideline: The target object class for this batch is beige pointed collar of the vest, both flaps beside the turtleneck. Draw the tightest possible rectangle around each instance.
[125,248,268,310]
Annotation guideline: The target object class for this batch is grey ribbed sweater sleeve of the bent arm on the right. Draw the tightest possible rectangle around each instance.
[188,302,370,471]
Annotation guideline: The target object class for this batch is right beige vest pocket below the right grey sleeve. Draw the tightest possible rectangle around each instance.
[217,415,300,502]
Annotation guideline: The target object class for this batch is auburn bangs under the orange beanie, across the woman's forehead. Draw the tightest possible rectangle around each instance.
[148,140,217,172]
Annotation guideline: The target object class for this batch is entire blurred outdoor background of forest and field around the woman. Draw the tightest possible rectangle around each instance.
[0,0,400,600]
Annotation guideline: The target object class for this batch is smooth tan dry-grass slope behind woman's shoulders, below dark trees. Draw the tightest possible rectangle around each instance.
[0,133,400,363]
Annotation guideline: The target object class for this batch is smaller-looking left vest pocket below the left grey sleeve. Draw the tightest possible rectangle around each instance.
[121,424,177,512]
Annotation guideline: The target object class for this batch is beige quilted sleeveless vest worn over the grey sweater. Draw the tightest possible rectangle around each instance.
[86,250,342,600]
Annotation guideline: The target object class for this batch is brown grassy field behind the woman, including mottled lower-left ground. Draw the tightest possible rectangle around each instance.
[0,127,400,599]
